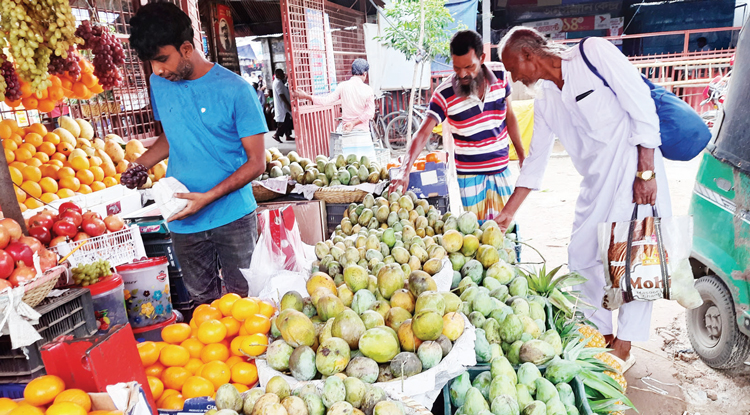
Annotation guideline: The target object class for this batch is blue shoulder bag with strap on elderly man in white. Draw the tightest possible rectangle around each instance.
[578,38,711,161]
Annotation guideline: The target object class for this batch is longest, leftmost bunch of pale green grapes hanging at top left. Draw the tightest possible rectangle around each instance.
[0,0,52,91]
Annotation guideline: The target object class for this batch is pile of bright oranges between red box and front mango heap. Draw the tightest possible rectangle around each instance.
[138,294,276,409]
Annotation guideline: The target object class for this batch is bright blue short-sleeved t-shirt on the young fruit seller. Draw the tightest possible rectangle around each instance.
[151,64,268,233]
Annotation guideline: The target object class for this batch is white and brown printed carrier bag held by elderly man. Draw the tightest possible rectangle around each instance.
[598,205,702,310]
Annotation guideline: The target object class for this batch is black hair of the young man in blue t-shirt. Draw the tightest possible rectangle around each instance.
[130,2,194,61]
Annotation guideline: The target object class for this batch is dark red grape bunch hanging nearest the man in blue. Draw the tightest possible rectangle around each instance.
[76,20,125,89]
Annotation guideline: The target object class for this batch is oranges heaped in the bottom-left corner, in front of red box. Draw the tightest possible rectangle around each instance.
[8,375,122,415]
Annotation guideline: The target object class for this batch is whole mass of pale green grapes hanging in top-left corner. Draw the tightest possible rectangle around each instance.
[0,0,79,92]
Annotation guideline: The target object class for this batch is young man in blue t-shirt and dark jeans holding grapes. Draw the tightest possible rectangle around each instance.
[128,2,268,304]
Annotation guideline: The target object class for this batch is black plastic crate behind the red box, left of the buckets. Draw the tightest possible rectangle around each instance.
[0,288,96,384]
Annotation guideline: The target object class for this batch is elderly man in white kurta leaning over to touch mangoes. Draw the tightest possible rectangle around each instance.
[499,28,671,369]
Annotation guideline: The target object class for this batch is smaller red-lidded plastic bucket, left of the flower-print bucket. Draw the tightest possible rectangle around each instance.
[88,274,128,334]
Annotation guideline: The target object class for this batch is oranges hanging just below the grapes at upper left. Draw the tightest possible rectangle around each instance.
[5,57,104,113]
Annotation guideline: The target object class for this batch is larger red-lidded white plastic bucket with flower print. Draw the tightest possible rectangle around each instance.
[117,257,172,329]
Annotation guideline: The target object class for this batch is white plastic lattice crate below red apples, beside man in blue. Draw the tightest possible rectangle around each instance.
[50,225,146,267]
